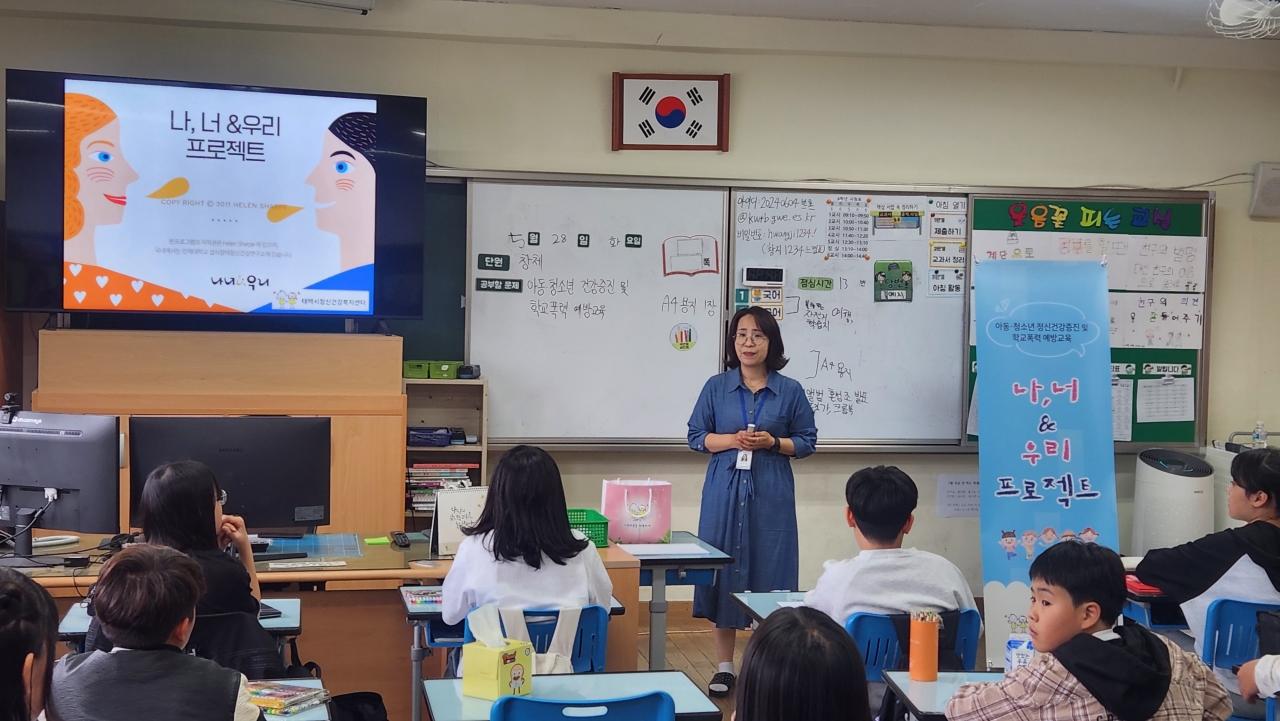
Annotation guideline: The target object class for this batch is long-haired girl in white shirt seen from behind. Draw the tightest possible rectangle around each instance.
[442,446,613,624]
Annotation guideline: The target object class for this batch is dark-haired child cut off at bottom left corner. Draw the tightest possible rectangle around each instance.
[0,569,58,721]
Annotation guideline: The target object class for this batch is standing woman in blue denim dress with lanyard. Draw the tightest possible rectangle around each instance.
[689,307,818,697]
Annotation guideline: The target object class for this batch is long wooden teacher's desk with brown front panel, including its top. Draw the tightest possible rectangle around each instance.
[24,529,640,718]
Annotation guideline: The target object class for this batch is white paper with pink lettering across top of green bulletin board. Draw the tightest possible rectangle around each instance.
[973,231,1208,293]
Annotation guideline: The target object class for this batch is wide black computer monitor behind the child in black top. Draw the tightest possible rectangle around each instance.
[128,416,329,530]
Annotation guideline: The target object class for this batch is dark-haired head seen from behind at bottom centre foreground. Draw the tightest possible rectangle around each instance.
[735,608,872,721]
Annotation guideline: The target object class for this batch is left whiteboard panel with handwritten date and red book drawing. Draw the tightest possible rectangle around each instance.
[467,182,728,443]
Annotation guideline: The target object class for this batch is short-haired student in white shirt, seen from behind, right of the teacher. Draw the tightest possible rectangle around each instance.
[805,466,977,626]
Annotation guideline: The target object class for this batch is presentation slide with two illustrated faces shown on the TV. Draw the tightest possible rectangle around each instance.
[63,79,378,316]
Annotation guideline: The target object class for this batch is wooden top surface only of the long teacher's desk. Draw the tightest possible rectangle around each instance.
[26,533,640,589]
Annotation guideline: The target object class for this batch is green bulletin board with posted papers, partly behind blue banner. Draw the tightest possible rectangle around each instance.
[969,197,1210,443]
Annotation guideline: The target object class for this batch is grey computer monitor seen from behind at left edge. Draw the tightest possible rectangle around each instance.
[0,411,123,566]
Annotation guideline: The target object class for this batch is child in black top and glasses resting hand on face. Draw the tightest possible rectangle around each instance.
[141,461,262,616]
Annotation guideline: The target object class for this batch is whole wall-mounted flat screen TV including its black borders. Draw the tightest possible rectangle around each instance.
[5,69,426,318]
